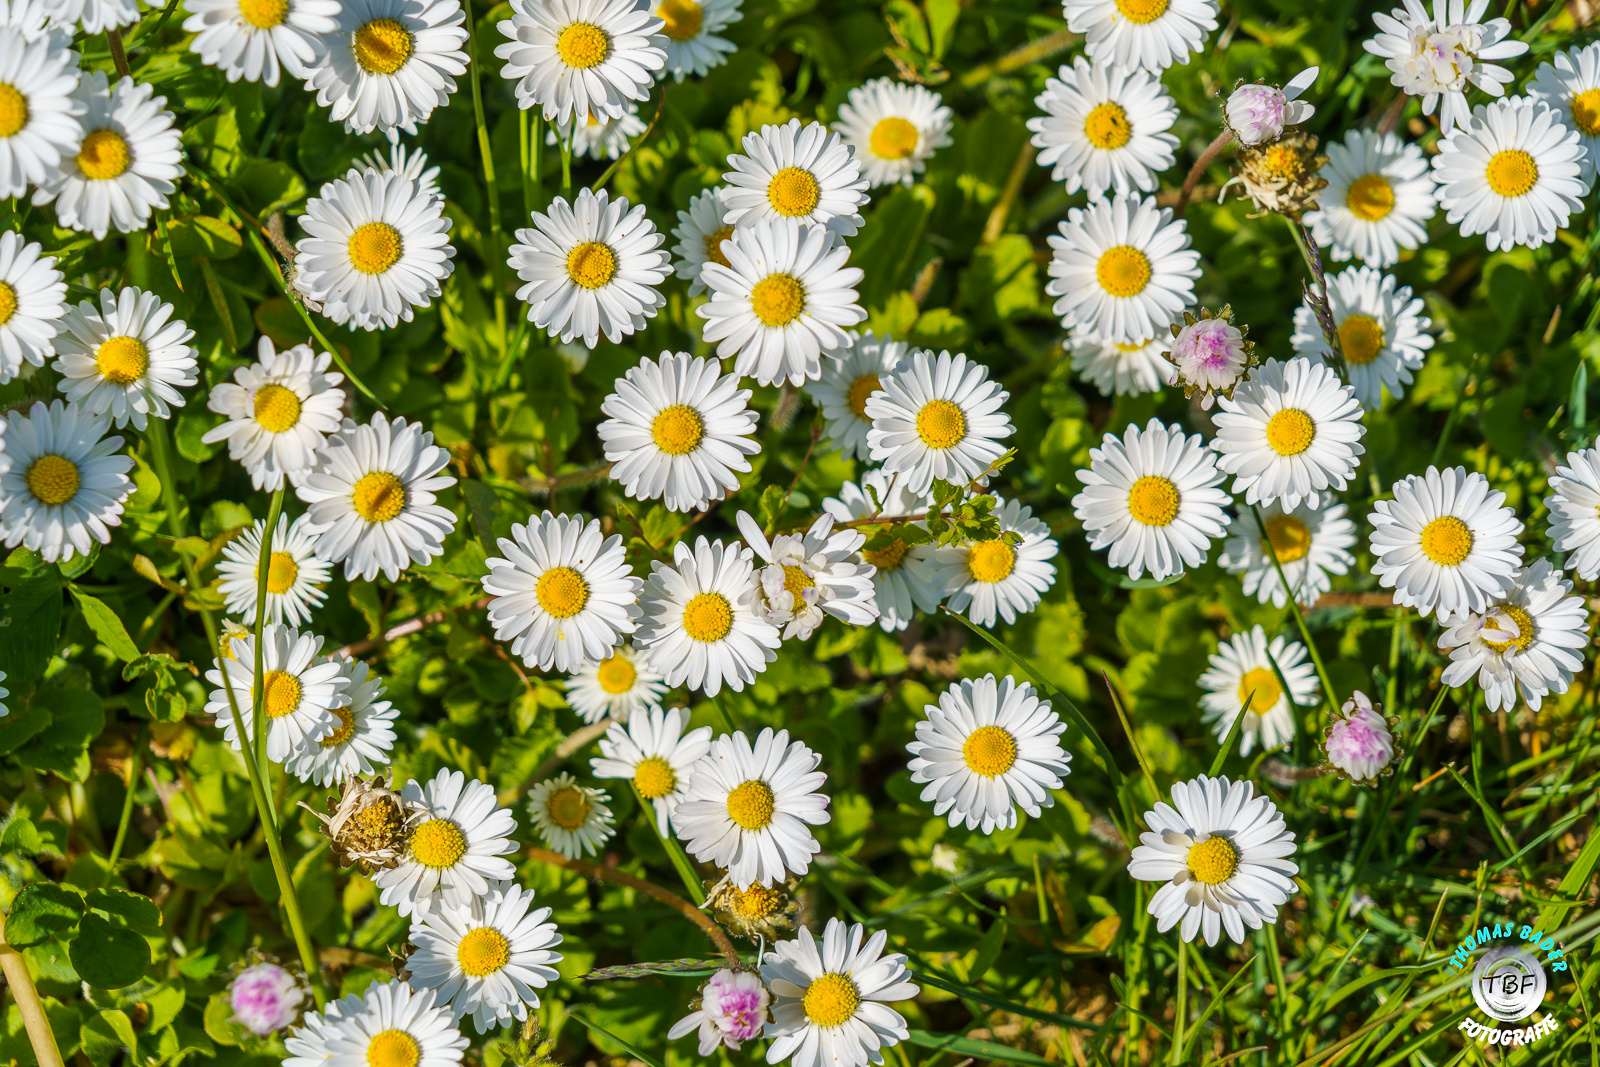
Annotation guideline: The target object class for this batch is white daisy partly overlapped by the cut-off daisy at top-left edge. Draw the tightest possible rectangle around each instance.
[34,70,184,240]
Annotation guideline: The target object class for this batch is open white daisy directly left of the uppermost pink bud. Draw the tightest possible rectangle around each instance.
[1027,56,1178,200]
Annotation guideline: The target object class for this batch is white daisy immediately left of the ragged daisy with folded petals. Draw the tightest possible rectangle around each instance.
[634,537,782,696]
